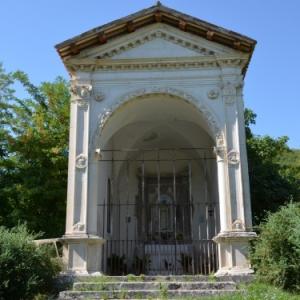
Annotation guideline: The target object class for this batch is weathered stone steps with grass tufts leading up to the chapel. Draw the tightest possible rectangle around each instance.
[58,275,237,300]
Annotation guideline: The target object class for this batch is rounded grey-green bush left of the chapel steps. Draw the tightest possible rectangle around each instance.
[0,225,60,300]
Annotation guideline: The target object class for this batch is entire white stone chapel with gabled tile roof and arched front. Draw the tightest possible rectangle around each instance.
[56,2,256,276]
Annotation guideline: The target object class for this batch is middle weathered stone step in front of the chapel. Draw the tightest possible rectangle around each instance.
[73,281,236,291]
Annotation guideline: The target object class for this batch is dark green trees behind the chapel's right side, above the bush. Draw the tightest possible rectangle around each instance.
[245,109,300,224]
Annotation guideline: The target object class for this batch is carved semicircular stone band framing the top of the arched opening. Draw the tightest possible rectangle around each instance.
[90,87,225,149]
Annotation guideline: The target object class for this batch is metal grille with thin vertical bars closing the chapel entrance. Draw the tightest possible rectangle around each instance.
[98,149,218,275]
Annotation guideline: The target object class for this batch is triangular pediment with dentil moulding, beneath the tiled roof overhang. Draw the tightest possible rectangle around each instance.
[78,24,239,59]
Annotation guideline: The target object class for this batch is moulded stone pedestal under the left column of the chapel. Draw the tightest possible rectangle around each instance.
[61,233,105,276]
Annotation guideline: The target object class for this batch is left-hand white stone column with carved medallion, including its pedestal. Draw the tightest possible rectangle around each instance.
[62,82,103,273]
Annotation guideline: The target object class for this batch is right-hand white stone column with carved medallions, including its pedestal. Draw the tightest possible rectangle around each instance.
[214,74,256,276]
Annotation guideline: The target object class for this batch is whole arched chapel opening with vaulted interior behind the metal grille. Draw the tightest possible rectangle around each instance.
[97,93,219,275]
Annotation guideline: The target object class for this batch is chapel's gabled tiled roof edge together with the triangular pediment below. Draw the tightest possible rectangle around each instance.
[55,2,256,74]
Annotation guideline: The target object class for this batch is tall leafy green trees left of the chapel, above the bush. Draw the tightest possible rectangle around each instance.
[0,65,70,237]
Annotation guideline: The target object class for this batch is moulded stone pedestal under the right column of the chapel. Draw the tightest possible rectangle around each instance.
[213,231,257,277]
